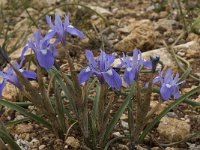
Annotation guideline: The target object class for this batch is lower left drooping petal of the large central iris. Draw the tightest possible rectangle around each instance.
[78,67,93,84]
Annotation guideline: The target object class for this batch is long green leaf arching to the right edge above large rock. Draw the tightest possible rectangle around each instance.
[138,86,200,143]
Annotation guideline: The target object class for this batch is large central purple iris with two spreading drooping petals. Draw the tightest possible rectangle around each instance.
[78,50,122,89]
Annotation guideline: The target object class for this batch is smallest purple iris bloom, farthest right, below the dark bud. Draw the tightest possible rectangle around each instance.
[153,68,185,100]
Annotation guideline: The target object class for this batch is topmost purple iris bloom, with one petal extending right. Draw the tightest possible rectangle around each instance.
[46,14,84,46]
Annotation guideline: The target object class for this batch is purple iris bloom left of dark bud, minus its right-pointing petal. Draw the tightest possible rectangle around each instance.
[120,49,143,85]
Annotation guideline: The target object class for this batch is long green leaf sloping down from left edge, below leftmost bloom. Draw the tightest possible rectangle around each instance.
[0,99,52,129]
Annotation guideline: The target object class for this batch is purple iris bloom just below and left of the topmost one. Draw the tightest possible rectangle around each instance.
[21,30,58,70]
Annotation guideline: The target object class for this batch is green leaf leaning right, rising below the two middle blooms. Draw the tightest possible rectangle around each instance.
[102,84,135,145]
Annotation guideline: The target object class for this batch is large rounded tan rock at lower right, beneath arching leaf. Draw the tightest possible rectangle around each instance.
[157,117,191,142]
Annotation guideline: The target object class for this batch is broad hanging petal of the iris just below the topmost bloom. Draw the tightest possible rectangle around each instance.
[36,50,54,70]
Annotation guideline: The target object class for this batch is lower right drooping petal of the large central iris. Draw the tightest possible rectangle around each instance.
[102,69,122,89]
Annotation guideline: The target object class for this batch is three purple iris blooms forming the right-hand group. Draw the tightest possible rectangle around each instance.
[79,49,184,100]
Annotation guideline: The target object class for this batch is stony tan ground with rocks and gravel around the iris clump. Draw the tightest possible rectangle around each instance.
[0,0,200,150]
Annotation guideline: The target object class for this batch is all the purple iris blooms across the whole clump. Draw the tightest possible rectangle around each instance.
[0,14,182,100]
